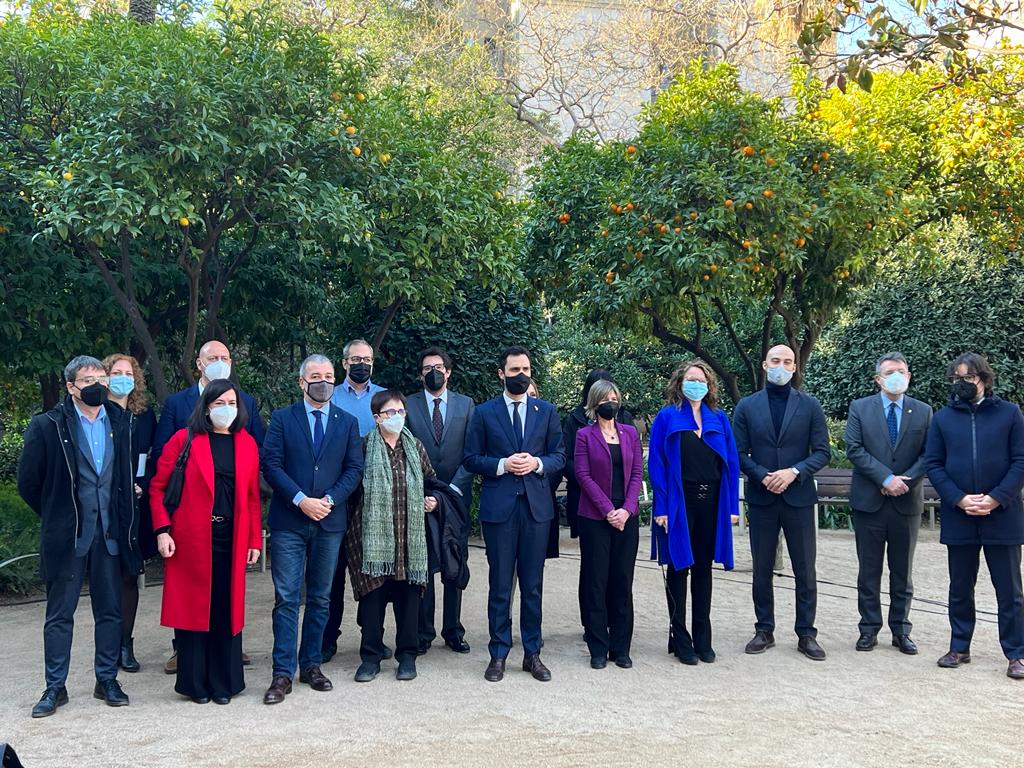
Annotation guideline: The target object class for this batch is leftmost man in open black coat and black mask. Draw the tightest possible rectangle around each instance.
[17,355,141,718]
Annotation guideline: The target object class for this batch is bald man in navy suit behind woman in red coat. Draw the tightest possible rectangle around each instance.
[151,341,263,675]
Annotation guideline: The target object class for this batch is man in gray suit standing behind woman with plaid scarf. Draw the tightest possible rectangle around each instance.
[406,347,473,655]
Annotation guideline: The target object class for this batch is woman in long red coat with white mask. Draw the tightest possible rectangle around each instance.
[150,379,262,705]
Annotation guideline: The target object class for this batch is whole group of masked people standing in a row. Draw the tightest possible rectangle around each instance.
[18,339,1024,717]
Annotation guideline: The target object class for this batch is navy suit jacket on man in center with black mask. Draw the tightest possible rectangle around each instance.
[462,395,565,522]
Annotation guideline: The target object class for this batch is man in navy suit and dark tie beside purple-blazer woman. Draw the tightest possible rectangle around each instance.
[463,347,565,682]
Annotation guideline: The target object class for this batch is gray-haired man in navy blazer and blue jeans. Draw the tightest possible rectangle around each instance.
[260,354,362,705]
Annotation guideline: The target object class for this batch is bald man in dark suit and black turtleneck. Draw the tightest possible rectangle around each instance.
[732,344,831,662]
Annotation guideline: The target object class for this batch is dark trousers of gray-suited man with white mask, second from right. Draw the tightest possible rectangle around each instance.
[853,499,921,635]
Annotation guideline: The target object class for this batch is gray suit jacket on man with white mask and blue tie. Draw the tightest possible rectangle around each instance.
[845,394,932,515]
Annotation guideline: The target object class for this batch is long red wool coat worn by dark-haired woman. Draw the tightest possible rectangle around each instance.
[150,429,262,635]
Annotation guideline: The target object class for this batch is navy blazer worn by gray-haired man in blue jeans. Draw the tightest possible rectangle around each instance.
[260,400,362,532]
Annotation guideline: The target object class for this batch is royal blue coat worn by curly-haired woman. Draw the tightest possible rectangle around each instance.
[647,403,739,570]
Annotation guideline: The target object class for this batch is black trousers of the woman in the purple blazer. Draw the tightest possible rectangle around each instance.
[577,516,640,658]
